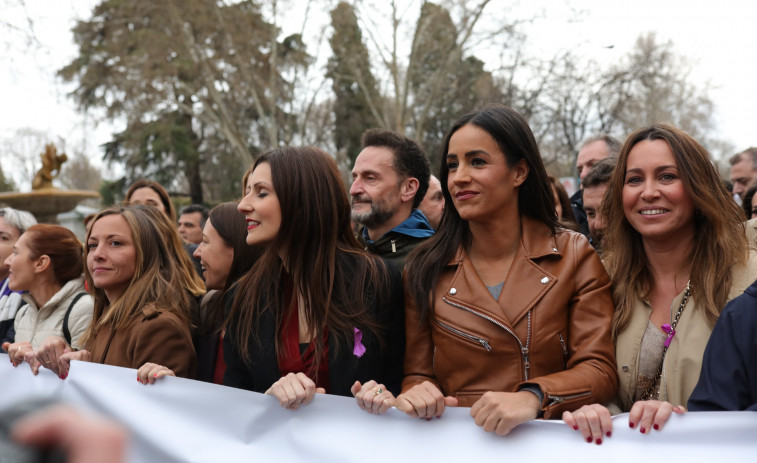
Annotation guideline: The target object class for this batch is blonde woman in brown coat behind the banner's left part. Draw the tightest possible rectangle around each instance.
[34,206,196,378]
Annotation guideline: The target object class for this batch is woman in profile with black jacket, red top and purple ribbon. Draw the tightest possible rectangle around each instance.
[223,147,404,413]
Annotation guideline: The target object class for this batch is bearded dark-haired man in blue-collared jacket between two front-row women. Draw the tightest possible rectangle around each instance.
[350,129,434,266]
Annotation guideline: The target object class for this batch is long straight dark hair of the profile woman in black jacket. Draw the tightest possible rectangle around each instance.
[227,147,388,373]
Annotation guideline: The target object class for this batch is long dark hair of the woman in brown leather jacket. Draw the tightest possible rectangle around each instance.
[405,105,558,320]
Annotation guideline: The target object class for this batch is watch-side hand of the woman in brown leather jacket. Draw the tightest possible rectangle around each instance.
[470,391,541,436]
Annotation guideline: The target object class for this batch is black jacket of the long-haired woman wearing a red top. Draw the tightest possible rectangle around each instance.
[223,263,405,397]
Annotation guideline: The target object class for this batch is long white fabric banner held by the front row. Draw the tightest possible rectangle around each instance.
[0,355,757,463]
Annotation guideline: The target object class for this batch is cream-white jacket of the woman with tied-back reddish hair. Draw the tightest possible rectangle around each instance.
[14,276,94,349]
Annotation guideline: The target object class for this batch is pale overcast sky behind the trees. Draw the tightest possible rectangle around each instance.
[0,0,757,188]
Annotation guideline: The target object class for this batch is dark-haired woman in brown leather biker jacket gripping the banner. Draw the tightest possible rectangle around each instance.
[396,105,618,435]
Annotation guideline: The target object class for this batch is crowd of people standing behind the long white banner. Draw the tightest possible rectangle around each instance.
[0,105,757,454]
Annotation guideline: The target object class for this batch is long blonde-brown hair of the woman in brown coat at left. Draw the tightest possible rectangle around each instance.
[79,206,189,348]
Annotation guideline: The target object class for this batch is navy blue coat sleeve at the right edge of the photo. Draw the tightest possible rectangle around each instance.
[688,282,757,411]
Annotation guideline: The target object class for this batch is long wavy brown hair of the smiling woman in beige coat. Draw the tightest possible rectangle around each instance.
[602,124,749,338]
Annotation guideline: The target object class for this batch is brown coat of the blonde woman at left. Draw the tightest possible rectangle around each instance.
[87,306,197,379]
